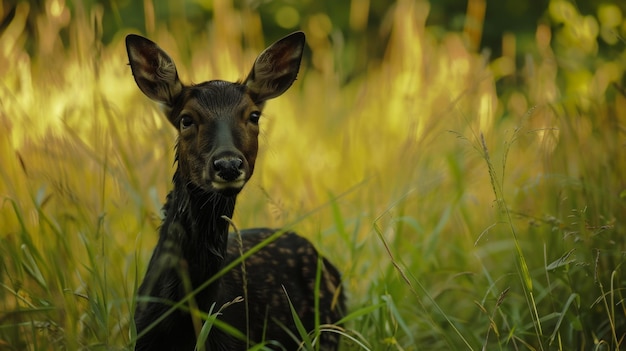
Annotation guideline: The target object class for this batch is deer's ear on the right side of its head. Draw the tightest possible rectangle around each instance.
[244,32,304,103]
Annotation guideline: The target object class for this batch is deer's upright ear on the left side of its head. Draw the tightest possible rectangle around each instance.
[126,34,183,107]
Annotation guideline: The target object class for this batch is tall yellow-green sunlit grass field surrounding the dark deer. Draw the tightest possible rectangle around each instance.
[0,0,626,350]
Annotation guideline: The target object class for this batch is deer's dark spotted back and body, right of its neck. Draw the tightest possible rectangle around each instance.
[213,228,345,350]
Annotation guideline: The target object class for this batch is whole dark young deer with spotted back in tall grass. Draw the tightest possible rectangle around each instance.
[126,32,344,350]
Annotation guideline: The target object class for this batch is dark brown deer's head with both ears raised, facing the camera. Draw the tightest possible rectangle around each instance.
[126,32,304,195]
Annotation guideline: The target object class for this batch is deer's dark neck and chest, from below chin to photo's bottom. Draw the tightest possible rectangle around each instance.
[135,171,235,350]
